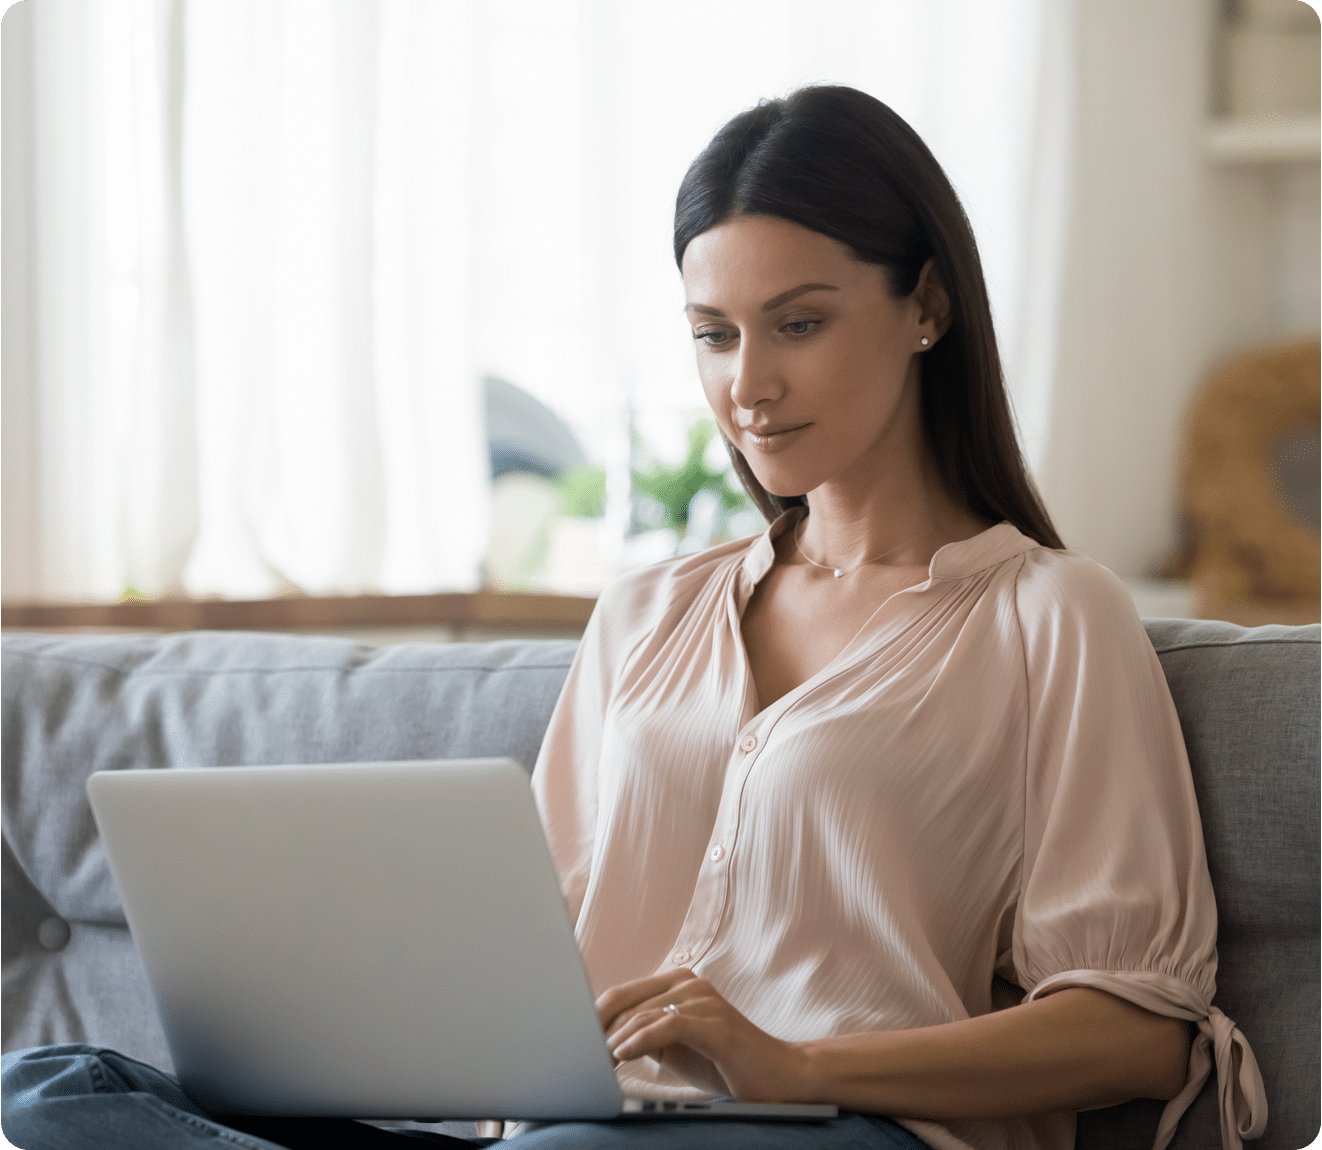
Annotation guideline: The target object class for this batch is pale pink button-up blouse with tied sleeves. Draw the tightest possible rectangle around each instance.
[533,510,1266,1150]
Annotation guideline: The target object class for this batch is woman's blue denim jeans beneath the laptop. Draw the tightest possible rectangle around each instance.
[0,1043,928,1150]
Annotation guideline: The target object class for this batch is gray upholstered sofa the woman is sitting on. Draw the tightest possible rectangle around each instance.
[0,620,1319,1150]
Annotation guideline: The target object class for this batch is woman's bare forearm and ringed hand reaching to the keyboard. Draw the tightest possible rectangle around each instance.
[598,970,1191,1121]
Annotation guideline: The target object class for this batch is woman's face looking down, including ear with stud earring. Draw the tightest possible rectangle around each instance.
[683,215,945,496]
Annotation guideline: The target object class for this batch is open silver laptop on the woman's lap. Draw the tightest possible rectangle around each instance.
[87,759,836,1121]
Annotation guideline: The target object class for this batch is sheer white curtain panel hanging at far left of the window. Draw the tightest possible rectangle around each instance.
[4,0,488,599]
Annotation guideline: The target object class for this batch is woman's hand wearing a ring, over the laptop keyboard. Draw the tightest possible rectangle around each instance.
[596,969,814,1102]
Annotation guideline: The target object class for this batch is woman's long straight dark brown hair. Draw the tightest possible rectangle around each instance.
[674,86,1064,547]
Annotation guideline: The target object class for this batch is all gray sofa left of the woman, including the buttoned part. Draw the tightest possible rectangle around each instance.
[0,632,576,1067]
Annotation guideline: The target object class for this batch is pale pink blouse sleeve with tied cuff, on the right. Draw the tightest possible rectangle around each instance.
[1011,550,1266,1150]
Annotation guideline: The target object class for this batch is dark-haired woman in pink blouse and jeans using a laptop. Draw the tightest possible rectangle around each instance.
[7,87,1265,1150]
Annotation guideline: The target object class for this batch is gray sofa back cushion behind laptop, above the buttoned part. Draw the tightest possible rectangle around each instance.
[3,632,575,923]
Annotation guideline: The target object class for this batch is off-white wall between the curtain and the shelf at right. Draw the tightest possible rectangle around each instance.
[1038,0,1322,575]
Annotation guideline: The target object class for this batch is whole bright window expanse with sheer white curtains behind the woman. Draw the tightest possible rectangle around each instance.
[0,0,1071,599]
